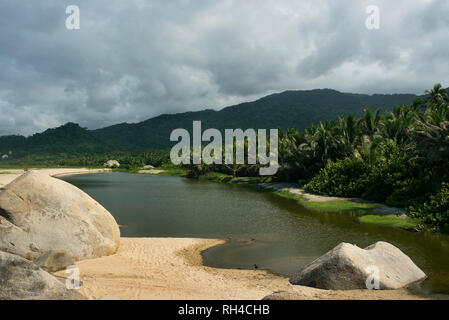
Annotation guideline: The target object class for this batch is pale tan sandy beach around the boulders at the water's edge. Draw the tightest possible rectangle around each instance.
[0,169,434,300]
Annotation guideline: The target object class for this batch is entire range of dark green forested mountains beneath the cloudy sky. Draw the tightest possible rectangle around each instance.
[0,89,418,158]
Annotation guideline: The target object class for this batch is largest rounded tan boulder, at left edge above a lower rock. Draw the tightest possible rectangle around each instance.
[0,171,120,260]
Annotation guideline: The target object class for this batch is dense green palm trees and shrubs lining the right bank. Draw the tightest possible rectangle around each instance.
[186,84,449,228]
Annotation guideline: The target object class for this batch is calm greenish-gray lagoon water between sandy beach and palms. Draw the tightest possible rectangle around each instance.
[64,173,449,293]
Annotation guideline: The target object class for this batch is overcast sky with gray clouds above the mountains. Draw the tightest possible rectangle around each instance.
[0,0,449,135]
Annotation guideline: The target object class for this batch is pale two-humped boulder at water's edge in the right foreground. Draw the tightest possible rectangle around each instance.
[290,242,426,290]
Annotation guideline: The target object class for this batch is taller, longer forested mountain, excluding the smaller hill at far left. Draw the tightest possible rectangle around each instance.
[94,89,417,149]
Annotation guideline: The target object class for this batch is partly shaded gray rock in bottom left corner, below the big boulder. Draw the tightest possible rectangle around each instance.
[0,252,85,300]
